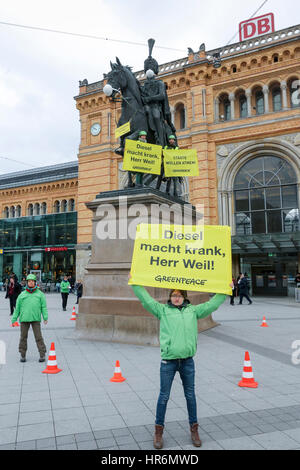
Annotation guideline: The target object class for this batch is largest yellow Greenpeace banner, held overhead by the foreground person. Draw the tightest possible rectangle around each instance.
[129,224,232,295]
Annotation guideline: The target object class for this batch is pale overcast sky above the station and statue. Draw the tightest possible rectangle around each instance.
[0,0,300,174]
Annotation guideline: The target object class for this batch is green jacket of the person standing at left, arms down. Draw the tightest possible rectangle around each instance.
[11,288,48,323]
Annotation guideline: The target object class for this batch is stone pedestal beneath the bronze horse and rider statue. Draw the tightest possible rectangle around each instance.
[75,187,217,346]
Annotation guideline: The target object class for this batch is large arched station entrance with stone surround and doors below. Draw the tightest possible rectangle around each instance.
[219,141,300,296]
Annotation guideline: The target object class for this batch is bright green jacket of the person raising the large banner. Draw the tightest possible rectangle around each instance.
[131,285,226,360]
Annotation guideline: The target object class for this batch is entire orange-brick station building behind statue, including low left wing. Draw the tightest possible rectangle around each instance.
[0,25,300,295]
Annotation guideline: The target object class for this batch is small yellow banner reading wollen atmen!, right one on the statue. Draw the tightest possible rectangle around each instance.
[163,149,199,177]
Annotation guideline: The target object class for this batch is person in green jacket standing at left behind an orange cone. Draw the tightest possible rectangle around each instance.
[12,274,48,362]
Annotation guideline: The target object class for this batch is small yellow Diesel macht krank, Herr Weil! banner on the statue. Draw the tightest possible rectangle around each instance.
[123,139,162,175]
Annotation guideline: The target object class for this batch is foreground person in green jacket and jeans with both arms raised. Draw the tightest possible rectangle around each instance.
[129,274,232,449]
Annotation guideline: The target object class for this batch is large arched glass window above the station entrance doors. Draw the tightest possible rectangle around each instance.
[234,156,299,235]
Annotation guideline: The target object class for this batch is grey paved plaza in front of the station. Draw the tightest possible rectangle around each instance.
[0,292,300,452]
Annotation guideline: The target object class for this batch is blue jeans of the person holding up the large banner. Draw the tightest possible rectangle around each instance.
[155,357,198,426]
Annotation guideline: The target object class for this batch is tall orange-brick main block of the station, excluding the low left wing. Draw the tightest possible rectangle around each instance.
[75,25,300,295]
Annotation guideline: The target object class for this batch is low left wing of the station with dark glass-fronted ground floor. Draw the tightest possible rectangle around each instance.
[0,161,78,282]
